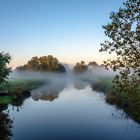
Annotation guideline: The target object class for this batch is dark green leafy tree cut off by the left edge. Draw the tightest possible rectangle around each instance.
[0,52,11,84]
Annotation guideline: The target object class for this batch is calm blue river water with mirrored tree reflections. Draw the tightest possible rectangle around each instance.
[1,83,140,140]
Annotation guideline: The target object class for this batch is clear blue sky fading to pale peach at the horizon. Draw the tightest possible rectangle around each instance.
[0,0,124,67]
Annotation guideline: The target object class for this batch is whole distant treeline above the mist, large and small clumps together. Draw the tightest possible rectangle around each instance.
[16,55,104,74]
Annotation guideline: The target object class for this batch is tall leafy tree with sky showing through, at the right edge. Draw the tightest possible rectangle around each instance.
[100,0,140,93]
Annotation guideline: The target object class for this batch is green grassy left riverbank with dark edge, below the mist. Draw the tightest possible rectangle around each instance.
[0,79,44,104]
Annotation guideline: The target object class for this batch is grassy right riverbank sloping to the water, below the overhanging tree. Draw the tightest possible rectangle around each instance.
[92,78,140,123]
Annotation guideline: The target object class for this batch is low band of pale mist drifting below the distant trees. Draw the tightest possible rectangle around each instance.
[9,66,117,83]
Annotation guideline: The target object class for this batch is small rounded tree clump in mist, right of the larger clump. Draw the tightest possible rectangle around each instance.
[73,61,87,74]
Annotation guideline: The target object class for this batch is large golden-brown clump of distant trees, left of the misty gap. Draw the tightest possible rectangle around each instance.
[16,55,66,72]
